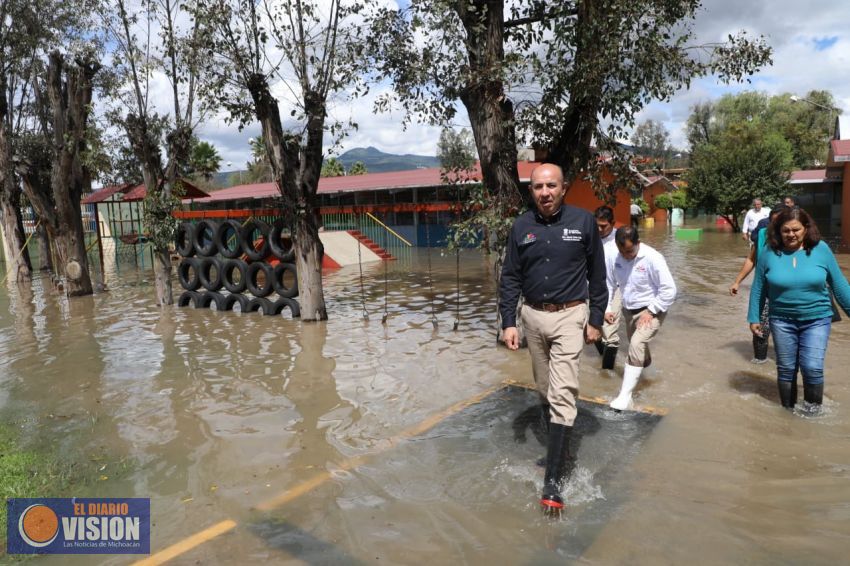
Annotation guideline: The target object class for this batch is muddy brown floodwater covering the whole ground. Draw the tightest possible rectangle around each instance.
[0,226,850,564]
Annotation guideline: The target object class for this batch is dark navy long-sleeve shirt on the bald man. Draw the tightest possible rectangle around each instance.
[499,204,608,328]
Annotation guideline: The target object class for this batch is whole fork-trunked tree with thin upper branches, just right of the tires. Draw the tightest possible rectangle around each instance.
[194,0,372,320]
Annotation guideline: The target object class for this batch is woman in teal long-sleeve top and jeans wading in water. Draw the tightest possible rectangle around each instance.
[747,208,850,408]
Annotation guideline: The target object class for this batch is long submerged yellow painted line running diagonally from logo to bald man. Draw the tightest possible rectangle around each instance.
[134,382,504,566]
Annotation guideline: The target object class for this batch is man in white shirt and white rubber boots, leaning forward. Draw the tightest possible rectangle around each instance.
[605,226,676,411]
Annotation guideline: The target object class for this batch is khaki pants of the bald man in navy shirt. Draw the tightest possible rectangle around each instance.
[522,304,588,426]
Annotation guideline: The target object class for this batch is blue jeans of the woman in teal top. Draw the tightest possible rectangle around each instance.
[770,317,832,385]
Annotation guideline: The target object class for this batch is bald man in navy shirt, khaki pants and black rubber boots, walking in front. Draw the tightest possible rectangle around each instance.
[499,164,608,512]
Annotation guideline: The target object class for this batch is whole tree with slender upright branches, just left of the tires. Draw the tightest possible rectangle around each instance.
[101,0,200,306]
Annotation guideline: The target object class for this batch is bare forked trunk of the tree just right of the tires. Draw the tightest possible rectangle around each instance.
[248,75,328,321]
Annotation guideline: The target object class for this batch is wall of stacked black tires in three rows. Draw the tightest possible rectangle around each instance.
[175,219,301,318]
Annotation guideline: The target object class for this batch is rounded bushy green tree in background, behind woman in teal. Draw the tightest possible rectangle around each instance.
[685,121,794,231]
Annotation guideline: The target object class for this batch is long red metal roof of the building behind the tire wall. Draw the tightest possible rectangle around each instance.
[184,161,540,202]
